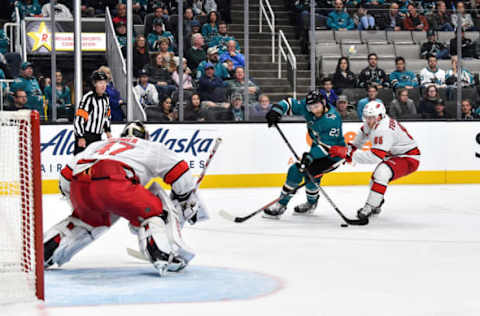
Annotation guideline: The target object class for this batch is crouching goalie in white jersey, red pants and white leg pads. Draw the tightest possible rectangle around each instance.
[44,121,206,275]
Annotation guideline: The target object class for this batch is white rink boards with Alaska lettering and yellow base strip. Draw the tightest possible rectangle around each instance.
[37,122,480,193]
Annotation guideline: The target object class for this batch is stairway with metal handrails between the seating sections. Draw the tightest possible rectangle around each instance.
[228,0,310,102]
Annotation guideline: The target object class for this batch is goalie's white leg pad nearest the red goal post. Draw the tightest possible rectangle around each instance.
[43,216,111,267]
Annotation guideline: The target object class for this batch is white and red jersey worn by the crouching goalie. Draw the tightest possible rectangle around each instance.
[70,137,195,195]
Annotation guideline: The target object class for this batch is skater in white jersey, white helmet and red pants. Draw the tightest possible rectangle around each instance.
[330,101,420,218]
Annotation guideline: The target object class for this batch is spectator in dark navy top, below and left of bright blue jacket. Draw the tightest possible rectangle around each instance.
[198,63,228,107]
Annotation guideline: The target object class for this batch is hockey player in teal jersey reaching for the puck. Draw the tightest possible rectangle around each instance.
[263,91,345,218]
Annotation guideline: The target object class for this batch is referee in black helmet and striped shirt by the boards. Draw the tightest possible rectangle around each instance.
[73,71,112,155]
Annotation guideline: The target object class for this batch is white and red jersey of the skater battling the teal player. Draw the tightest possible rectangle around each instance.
[352,115,420,164]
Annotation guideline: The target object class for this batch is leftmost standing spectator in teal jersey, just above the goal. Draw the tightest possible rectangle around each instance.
[11,62,45,118]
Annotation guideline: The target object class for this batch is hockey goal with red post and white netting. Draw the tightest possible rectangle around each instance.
[0,110,44,304]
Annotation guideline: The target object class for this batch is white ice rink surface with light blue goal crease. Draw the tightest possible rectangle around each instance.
[0,185,480,316]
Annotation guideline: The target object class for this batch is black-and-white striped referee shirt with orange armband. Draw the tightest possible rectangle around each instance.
[73,91,111,137]
